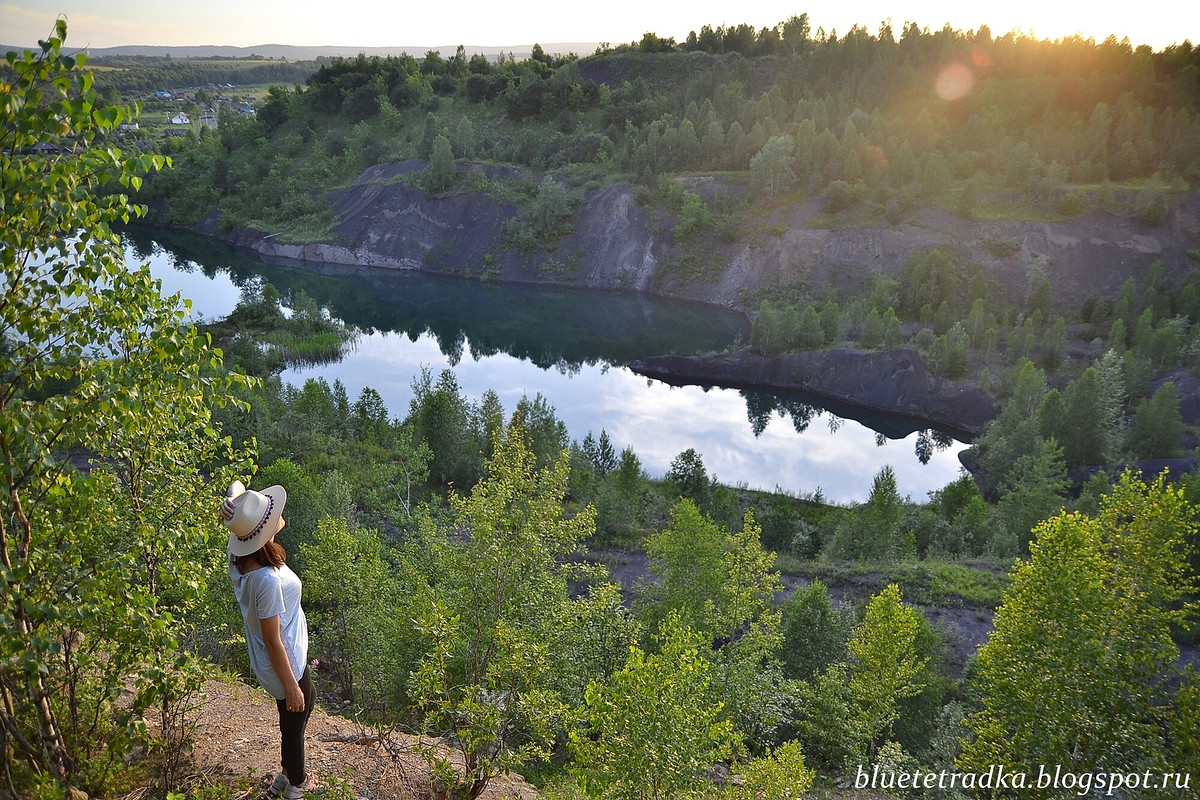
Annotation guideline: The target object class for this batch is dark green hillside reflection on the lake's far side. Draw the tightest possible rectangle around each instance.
[125,227,749,374]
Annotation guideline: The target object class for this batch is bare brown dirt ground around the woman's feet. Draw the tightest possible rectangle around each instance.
[187,679,539,800]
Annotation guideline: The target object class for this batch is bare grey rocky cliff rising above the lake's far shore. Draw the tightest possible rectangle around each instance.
[235,161,1200,308]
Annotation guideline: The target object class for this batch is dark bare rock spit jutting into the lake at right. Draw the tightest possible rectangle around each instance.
[630,348,996,438]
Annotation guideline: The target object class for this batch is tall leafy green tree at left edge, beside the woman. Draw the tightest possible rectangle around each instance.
[0,25,246,795]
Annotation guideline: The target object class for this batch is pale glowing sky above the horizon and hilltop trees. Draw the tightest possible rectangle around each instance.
[0,0,1200,49]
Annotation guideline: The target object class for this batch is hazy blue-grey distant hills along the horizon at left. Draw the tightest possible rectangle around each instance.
[0,42,598,61]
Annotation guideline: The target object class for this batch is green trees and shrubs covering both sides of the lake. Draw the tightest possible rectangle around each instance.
[0,17,1200,800]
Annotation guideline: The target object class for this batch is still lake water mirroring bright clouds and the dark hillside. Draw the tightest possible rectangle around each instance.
[125,227,965,503]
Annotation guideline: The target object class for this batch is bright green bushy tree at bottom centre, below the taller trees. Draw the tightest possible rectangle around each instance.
[570,615,740,800]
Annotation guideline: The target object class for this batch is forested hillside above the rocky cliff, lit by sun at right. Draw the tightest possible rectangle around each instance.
[145,18,1200,237]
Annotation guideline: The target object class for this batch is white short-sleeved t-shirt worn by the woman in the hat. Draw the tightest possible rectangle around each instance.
[229,558,308,700]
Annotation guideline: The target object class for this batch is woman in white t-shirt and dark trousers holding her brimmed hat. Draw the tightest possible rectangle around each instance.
[221,481,317,800]
